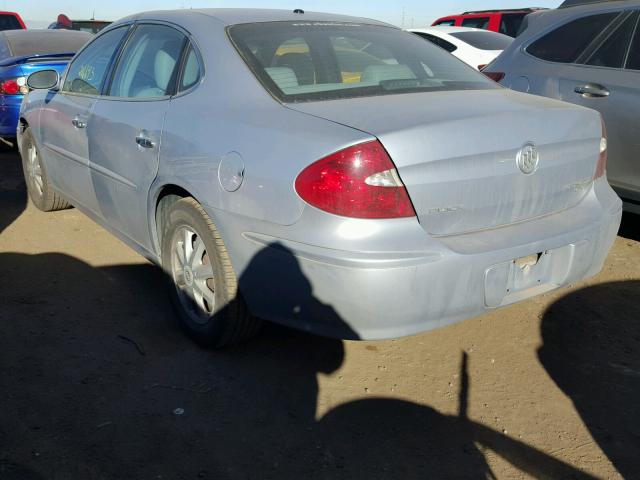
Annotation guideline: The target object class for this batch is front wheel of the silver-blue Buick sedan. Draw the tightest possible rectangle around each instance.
[20,127,71,212]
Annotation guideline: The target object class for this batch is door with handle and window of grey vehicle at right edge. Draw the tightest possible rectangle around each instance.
[559,12,640,199]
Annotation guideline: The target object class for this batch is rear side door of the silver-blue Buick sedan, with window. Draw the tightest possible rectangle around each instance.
[89,23,187,248]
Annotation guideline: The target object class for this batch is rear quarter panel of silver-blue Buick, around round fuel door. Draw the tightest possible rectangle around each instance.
[149,17,372,246]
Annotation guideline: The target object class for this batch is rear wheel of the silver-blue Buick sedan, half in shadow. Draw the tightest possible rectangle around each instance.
[162,197,261,348]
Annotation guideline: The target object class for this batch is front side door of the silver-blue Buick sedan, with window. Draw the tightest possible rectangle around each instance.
[40,26,128,211]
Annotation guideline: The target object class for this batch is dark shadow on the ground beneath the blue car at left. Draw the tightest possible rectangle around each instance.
[0,143,27,234]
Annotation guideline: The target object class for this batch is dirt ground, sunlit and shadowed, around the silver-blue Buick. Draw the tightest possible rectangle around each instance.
[0,147,640,480]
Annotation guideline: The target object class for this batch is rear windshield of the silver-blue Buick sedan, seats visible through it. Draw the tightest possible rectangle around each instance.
[229,22,499,102]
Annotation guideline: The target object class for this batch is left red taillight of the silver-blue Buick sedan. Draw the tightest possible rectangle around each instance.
[295,140,416,218]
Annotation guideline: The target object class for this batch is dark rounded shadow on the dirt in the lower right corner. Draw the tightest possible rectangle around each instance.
[538,281,640,478]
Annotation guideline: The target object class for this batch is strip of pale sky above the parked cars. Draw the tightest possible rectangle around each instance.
[15,0,561,28]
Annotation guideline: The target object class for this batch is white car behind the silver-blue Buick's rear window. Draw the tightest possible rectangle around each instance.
[409,27,513,70]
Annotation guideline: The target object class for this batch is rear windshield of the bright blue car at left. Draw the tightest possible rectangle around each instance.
[3,30,93,57]
